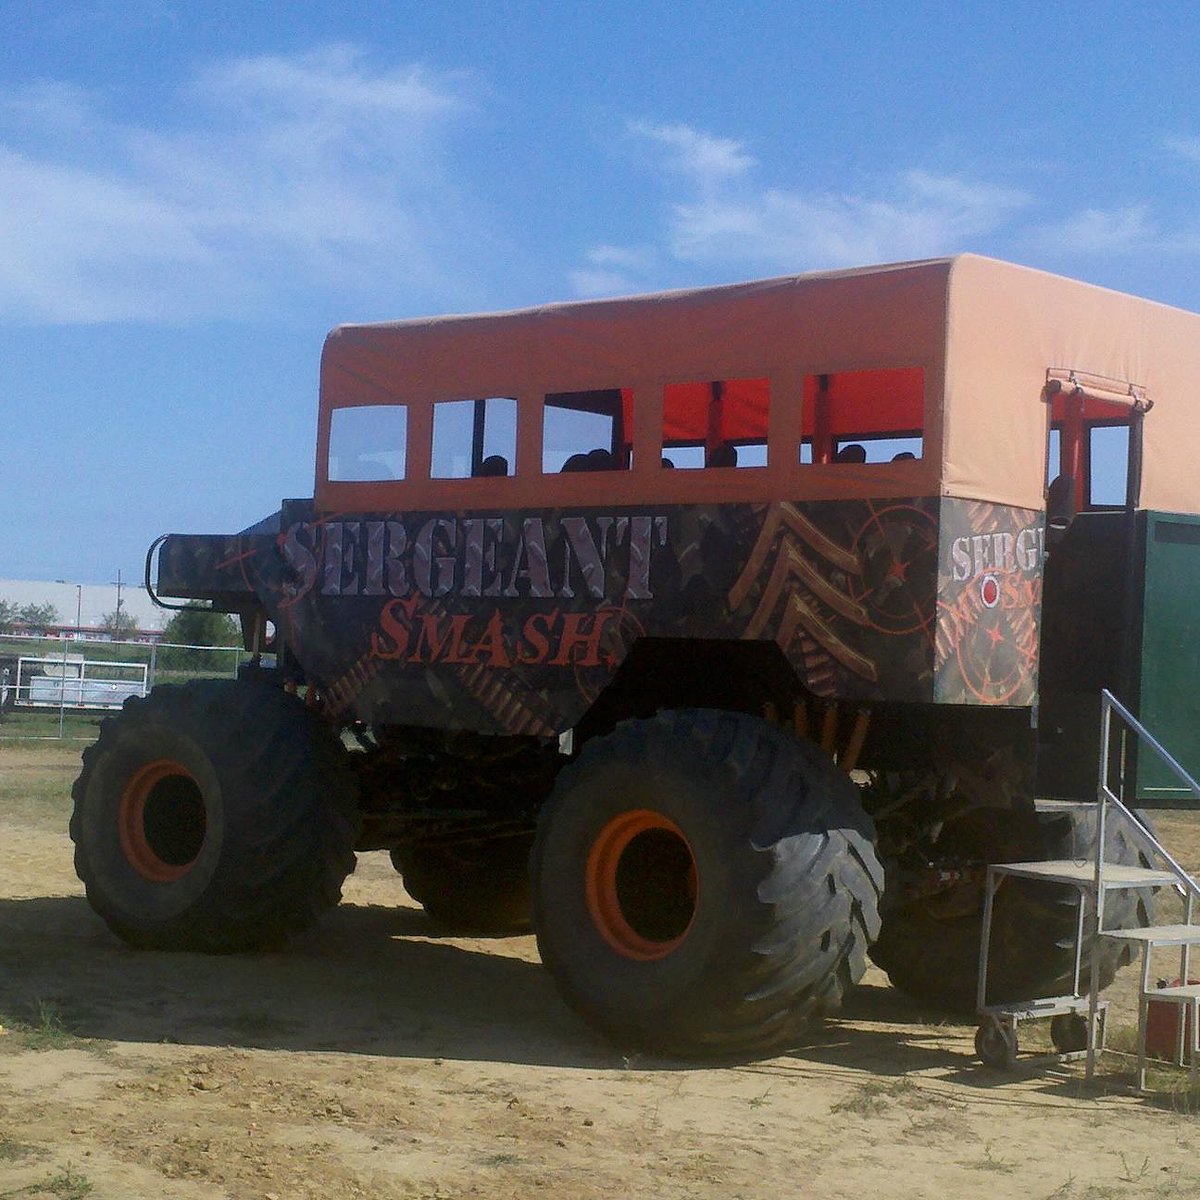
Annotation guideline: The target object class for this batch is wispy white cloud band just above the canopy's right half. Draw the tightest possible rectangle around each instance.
[600,122,1200,295]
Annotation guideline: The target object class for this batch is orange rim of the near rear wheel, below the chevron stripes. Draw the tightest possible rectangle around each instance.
[587,809,700,962]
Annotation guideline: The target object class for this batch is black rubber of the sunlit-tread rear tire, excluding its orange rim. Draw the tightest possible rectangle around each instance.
[533,709,883,1056]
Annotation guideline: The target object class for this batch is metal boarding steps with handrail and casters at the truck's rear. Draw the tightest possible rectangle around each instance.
[976,691,1200,1091]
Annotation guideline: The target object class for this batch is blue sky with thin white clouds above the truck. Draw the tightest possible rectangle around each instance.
[0,0,1200,582]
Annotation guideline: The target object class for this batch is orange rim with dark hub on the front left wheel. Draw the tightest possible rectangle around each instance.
[116,758,205,883]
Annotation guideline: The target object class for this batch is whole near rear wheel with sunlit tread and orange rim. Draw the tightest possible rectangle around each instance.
[532,709,883,1056]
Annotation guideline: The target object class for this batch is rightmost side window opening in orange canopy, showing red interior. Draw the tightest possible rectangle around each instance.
[799,367,925,463]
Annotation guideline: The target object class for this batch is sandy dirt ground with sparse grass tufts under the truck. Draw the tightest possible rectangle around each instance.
[0,744,1200,1200]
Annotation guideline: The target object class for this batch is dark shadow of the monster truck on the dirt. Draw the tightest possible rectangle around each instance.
[0,896,964,1074]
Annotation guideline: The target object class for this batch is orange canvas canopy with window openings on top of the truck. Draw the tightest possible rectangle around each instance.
[317,254,1200,512]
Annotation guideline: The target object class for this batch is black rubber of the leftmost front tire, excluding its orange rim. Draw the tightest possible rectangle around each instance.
[71,680,359,953]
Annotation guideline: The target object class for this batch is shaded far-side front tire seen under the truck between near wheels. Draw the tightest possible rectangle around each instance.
[391,835,533,935]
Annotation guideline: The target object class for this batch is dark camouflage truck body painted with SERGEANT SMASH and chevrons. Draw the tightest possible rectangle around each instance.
[158,489,1044,738]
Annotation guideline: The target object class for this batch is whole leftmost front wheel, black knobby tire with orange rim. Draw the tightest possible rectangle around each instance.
[71,679,358,953]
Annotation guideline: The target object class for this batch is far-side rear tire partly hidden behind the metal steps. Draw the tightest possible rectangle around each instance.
[871,805,1154,1014]
